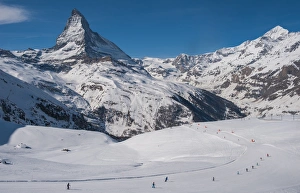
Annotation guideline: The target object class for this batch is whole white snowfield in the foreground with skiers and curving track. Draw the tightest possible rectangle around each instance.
[0,117,300,193]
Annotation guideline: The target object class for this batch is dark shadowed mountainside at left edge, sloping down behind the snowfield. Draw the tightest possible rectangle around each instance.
[0,70,92,129]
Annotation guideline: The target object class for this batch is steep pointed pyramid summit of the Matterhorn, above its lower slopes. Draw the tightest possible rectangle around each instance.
[54,9,131,60]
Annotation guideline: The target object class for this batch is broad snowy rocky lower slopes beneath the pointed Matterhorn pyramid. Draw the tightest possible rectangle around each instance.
[0,46,243,137]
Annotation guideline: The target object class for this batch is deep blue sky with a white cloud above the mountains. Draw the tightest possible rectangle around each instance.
[0,0,300,58]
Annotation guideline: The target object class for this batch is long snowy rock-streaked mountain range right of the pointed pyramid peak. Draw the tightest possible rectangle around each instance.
[140,26,300,116]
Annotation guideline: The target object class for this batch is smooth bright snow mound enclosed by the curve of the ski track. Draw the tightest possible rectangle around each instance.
[124,125,246,163]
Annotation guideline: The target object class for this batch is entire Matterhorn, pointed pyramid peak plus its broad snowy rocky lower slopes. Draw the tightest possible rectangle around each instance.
[0,9,244,137]
